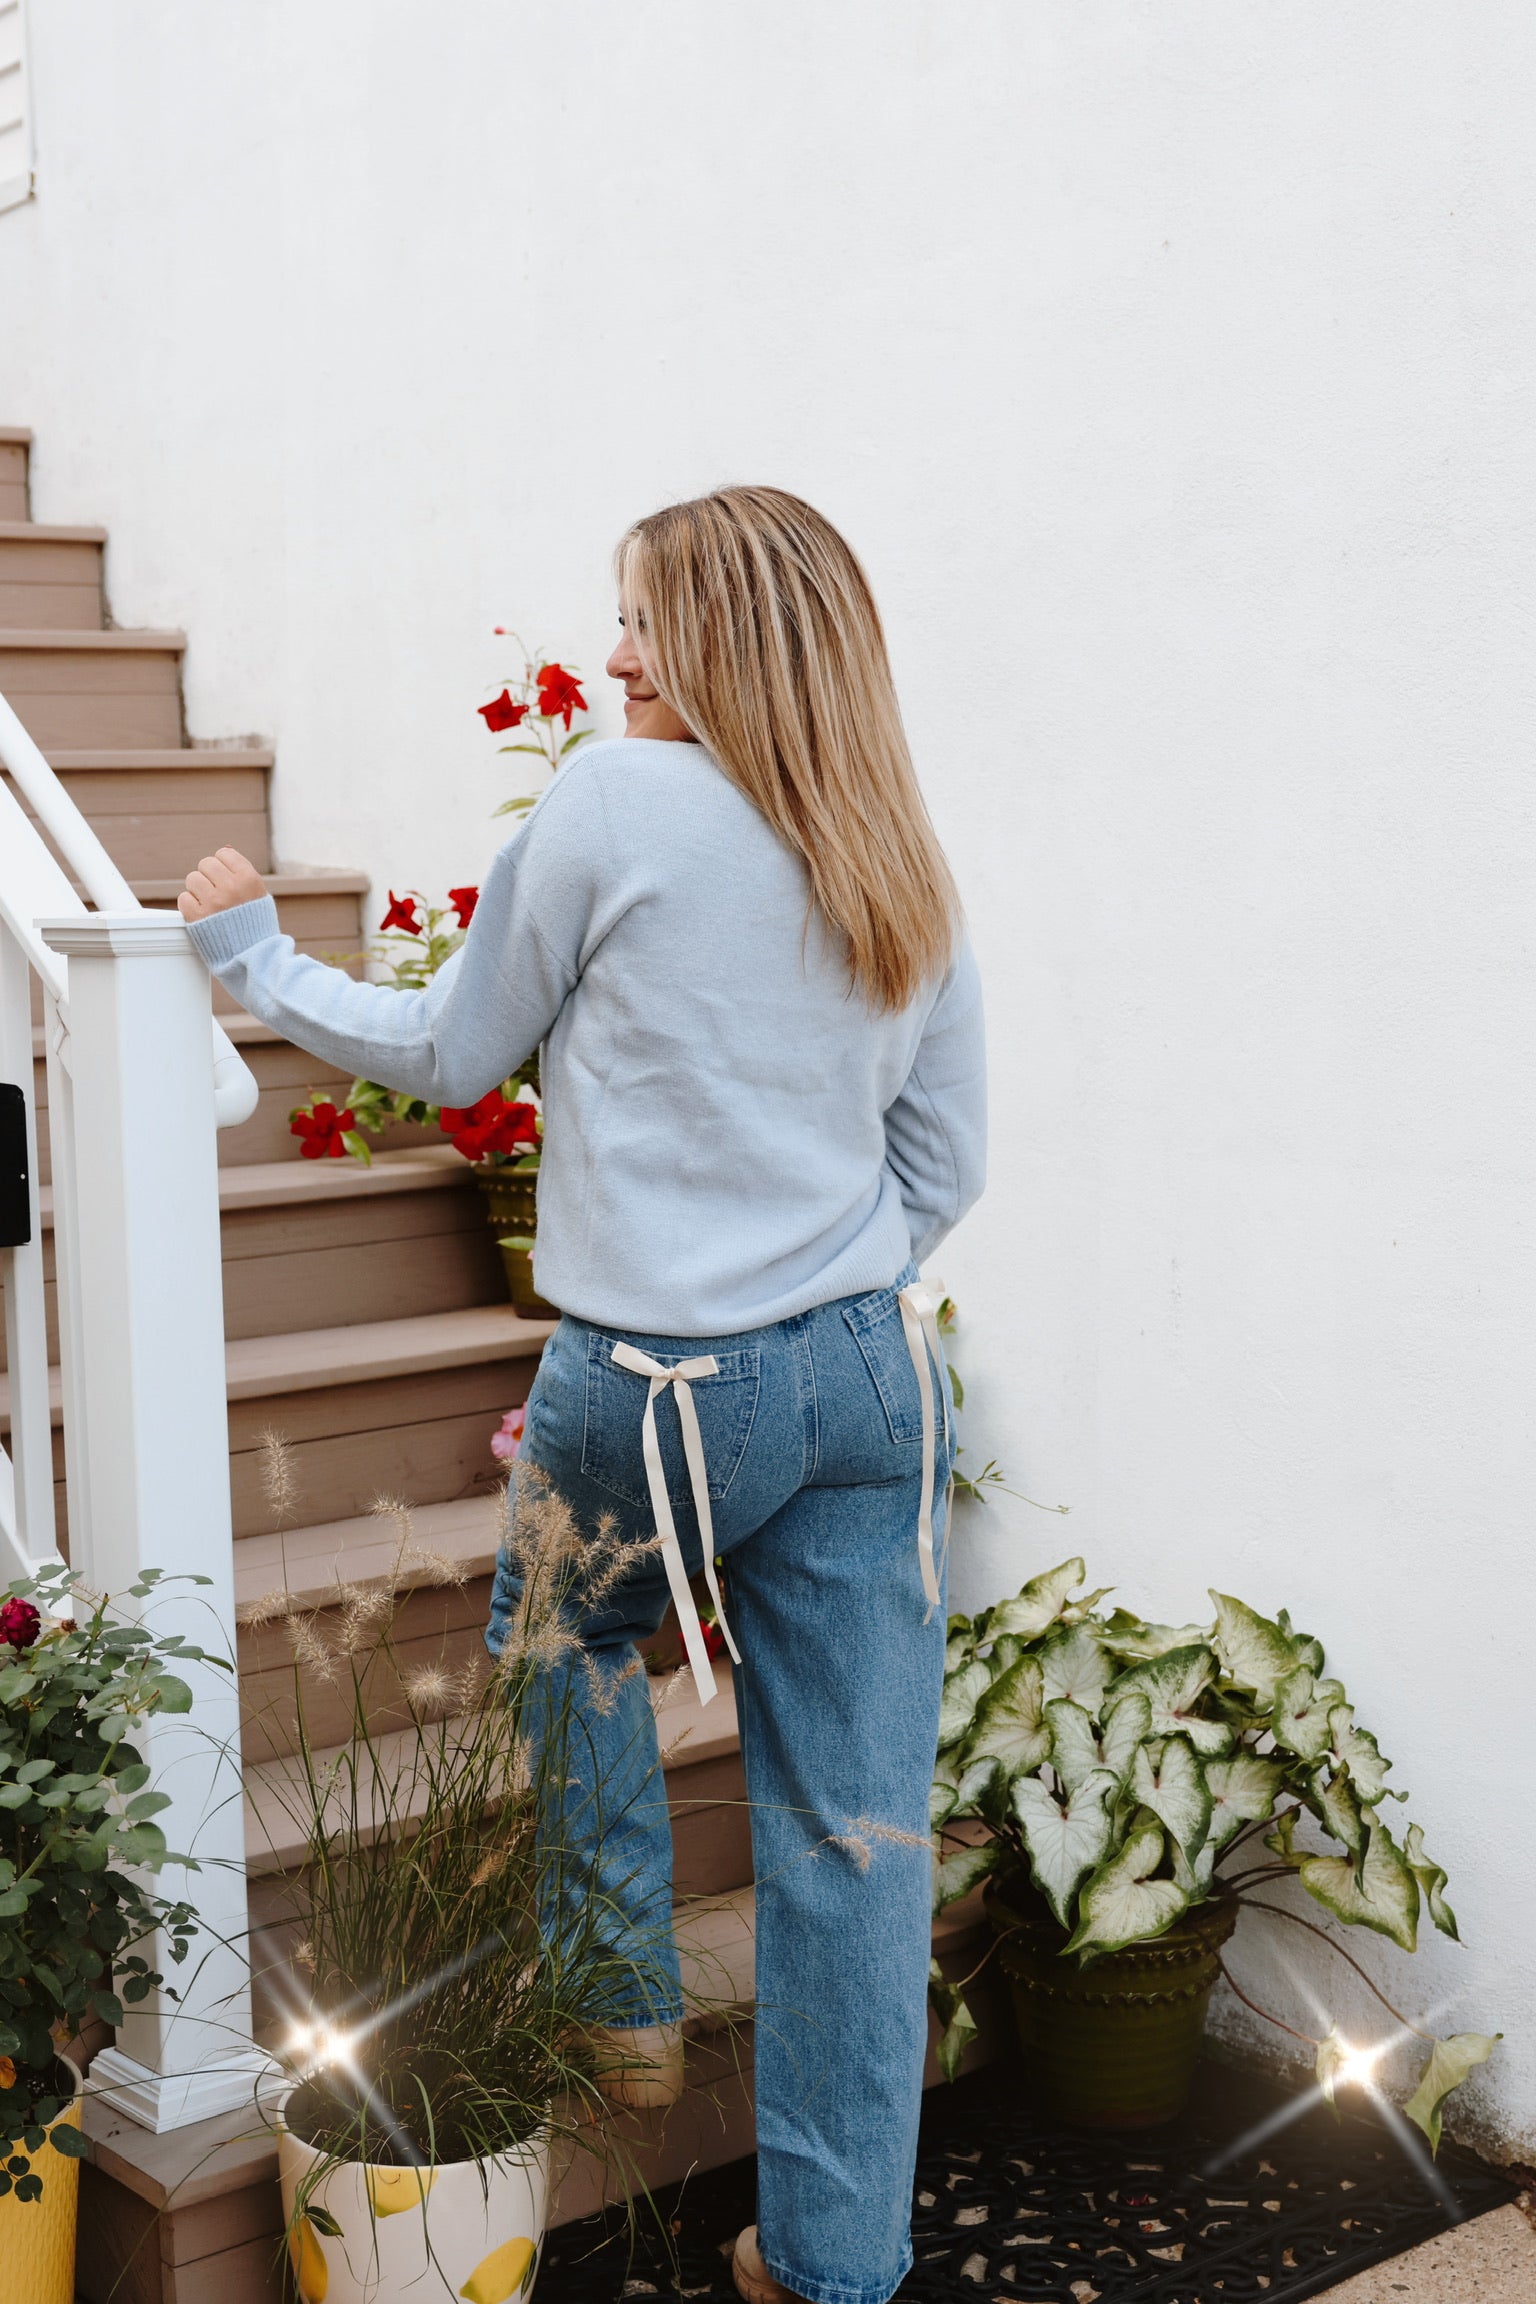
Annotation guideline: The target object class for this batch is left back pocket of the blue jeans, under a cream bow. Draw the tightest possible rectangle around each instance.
[580,1334,762,1505]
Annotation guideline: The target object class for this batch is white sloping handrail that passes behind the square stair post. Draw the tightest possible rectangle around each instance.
[0,696,258,1129]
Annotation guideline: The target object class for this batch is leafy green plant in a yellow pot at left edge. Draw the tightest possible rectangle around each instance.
[0,1567,218,2304]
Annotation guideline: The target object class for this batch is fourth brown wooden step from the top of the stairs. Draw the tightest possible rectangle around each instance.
[7,744,272,885]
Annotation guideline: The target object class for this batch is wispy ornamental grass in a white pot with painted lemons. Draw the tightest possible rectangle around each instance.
[246,1442,668,2304]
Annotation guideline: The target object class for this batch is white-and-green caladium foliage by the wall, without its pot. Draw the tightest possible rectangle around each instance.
[930,1560,1499,2145]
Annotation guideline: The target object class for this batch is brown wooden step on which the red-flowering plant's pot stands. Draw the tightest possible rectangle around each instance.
[0,1308,550,1537]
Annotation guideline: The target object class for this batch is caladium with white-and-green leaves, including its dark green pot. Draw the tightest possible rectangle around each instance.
[933,1560,1497,2145]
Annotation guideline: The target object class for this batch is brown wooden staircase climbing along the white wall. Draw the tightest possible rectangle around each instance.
[0,431,999,2304]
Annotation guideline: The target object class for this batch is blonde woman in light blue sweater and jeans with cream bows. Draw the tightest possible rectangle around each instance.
[180,488,983,2304]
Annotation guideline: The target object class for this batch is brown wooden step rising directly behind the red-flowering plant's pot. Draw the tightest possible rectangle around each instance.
[12,1138,507,1369]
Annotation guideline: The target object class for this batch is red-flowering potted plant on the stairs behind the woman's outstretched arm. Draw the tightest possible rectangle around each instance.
[288,624,592,1320]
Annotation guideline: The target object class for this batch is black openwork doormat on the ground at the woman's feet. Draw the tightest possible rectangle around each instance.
[537,2064,1515,2304]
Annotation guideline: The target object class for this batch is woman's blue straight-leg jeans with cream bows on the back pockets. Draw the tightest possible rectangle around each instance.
[486,1270,949,2304]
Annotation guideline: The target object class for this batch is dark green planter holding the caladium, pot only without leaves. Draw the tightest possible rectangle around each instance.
[986,1880,1237,2129]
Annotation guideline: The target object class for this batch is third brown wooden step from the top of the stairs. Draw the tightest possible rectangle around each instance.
[0,631,187,751]
